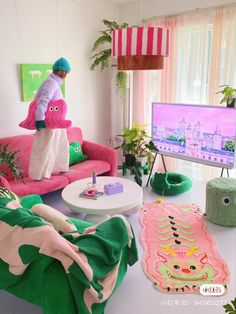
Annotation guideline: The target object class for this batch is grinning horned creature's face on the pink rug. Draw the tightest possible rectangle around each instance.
[157,249,215,289]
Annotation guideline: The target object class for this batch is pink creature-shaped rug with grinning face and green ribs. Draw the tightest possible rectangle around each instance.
[140,203,229,294]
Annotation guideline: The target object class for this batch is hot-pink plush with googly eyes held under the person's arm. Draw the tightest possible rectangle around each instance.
[19,99,71,130]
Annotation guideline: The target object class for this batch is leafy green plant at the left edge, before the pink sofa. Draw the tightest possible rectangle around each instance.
[0,144,23,180]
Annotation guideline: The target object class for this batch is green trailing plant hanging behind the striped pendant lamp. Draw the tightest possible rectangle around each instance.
[90,19,129,98]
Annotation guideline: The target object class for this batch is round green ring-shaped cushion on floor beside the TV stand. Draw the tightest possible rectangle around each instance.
[150,172,192,195]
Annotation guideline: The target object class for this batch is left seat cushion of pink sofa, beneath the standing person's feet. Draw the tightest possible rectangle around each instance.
[11,175,69,196]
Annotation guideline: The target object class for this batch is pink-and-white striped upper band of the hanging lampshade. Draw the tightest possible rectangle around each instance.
[112,27,169,57]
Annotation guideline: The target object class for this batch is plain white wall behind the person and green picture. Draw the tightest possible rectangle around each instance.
[0,0,118,143]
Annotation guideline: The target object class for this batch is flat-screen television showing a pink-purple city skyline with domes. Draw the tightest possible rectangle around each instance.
[152,103,236,169]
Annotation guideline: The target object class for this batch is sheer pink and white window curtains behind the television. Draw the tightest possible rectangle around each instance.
[133,4,236,180]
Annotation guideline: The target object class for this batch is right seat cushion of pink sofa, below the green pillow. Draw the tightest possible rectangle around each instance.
[63,160,111,183]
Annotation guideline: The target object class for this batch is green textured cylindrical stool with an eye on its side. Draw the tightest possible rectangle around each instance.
[206,178,236,227]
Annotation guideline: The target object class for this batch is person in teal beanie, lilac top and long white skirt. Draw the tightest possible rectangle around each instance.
[28,58,71,180]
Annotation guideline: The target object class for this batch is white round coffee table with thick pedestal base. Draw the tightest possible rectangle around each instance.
[62,176,143,223]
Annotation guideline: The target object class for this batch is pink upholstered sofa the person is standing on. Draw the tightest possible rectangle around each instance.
[0,127,118,196]
